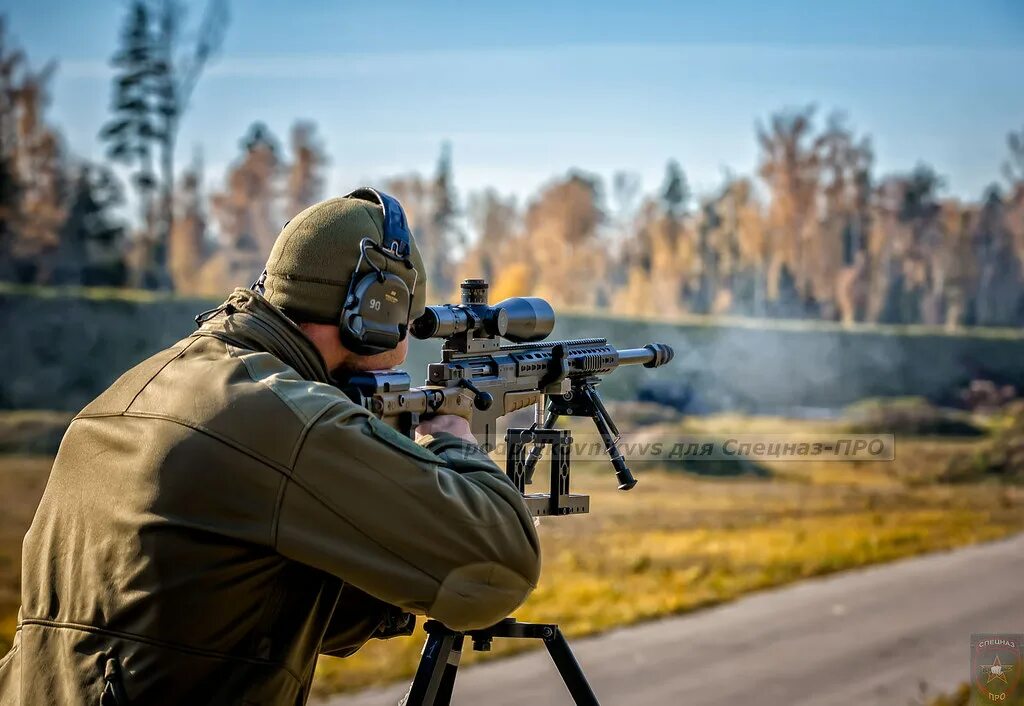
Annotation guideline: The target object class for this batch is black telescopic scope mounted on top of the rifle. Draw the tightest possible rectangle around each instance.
[410,280,555,343]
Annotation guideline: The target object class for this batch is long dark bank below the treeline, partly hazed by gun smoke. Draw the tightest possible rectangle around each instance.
[0,290,1024,412]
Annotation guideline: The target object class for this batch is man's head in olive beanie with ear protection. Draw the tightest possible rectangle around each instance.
[263,190,426,372]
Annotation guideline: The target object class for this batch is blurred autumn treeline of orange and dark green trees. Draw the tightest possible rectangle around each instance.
[0,6,1024,327]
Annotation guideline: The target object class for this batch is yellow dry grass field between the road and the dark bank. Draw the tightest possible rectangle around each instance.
[0,405,1024,694]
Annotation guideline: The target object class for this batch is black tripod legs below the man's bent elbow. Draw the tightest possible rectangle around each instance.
[404,618,599,706]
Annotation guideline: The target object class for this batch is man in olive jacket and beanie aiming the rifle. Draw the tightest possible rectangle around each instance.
[0,190,540,706]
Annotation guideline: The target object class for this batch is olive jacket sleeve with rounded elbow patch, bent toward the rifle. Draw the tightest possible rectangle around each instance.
[275,402,541,630]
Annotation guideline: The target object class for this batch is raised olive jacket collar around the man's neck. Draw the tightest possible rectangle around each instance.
[193,288,331,382]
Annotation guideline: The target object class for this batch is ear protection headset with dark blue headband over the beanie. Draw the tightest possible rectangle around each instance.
[338,188,419,356]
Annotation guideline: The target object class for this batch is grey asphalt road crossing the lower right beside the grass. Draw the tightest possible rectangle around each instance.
[329,535,1024,706]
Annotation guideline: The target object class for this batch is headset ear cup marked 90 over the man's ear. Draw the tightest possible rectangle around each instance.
[338,273,412,356]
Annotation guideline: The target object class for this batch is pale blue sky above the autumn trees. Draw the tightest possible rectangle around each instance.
[0,0,1024,206]
